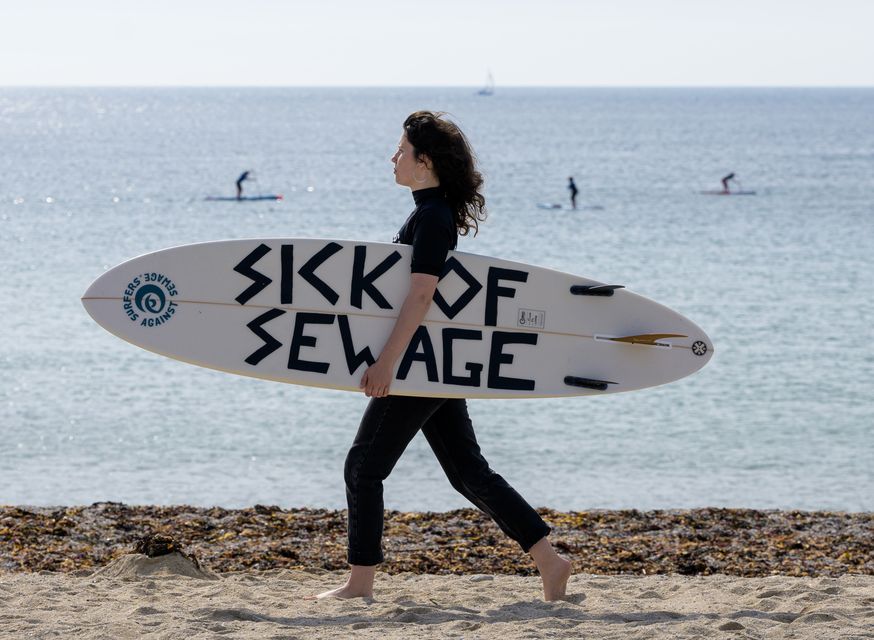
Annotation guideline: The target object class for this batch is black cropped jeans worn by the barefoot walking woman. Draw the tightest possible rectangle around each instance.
[344,396,549,566]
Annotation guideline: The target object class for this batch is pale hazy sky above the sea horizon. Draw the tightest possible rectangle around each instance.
[0,0,874,87]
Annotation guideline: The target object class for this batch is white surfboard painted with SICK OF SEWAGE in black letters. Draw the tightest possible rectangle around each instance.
[82,238,713,398]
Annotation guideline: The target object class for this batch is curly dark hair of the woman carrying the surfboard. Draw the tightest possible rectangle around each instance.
[404,111,486,236]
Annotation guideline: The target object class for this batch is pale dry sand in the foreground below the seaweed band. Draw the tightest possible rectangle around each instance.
[0,554,874,640]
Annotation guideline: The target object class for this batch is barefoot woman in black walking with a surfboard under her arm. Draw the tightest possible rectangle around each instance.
[316,111,571,600]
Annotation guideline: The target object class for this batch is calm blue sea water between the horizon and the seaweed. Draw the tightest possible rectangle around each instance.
[0,89,874,510]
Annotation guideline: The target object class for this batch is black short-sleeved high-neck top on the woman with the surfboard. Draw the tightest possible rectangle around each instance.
[394,187,458,277]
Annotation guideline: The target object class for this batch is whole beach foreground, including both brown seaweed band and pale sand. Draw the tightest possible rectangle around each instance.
[0,503,874,640]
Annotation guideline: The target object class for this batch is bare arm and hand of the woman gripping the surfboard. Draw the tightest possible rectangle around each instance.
[358,273,440,398]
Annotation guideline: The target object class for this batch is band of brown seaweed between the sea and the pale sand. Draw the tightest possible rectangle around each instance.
[0,502,874,577]
